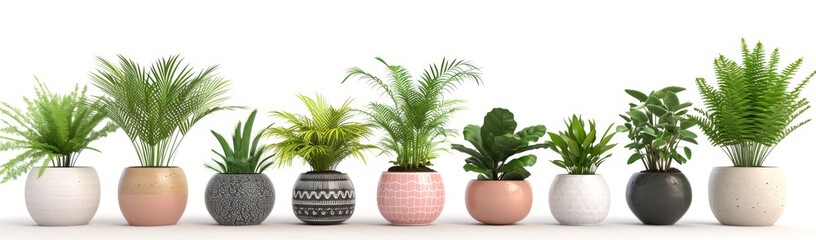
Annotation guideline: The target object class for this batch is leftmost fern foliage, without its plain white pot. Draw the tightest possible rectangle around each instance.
[0,79,116,182]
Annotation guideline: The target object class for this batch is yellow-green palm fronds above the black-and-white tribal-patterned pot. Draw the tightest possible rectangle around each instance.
[264,95,376,172]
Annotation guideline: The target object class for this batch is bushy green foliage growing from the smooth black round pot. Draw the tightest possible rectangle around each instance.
[617,87,697,172]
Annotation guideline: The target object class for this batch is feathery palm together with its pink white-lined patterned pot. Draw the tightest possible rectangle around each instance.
[343,58,481,225]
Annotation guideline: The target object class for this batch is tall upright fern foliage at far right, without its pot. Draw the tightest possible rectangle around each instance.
[691,39,816,167]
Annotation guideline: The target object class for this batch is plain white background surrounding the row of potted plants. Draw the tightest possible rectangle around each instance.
[0,0,816,239]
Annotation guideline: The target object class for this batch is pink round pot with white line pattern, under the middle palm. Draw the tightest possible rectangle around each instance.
[377,172,445,225]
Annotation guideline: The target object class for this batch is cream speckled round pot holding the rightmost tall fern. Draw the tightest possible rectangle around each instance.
[708,167,787,226]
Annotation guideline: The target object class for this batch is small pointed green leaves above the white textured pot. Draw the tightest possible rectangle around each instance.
[547,115,617,175]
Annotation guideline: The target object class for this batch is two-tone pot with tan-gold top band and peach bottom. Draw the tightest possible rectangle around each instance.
[119,167,187,226]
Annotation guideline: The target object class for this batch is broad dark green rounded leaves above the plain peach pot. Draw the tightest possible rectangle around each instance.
[451,108,547,180]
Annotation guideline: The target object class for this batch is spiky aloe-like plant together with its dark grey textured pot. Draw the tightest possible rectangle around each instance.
[204,110,275,226]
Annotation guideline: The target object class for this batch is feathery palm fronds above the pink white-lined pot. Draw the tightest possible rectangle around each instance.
[343,57,482,171]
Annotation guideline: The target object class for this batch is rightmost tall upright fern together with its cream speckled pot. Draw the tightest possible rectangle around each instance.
[691,39,816,226]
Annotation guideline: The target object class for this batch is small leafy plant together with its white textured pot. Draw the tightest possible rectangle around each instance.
[547,115,617,225]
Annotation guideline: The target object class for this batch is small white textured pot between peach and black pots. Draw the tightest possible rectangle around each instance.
[550,174,609,225]
